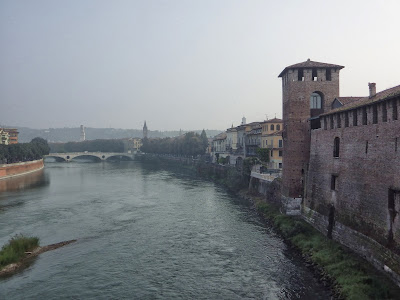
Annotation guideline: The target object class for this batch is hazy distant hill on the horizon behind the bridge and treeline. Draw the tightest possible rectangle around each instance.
[0,125,221,143]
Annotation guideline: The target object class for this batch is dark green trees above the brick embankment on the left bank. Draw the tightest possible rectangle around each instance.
[0,137,50,164]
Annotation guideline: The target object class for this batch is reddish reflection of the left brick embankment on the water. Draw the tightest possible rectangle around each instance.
[0,169,50,193]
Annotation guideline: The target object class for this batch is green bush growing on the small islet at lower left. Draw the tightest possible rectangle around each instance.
[0,234,39,270]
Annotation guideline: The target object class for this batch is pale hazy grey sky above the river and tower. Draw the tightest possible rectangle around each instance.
[0,0,400,130]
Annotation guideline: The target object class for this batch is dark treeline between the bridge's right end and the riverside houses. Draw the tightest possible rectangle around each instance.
[140,130,208,156]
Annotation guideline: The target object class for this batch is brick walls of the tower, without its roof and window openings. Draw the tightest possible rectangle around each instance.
[282,69,339,198]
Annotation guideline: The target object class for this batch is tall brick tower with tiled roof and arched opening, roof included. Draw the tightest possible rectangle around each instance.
[279,59,344,199]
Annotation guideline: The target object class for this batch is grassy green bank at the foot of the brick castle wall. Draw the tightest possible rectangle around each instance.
[252,197,400,300]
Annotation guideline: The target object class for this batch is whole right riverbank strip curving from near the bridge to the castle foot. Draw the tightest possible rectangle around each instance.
[137,157,400,299]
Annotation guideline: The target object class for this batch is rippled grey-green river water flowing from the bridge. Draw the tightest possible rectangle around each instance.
[0,161,329,299]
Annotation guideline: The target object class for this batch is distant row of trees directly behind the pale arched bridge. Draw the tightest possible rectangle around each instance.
[49,140,124,153]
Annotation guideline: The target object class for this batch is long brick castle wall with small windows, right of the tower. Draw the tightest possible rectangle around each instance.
[304,96,400,258]
